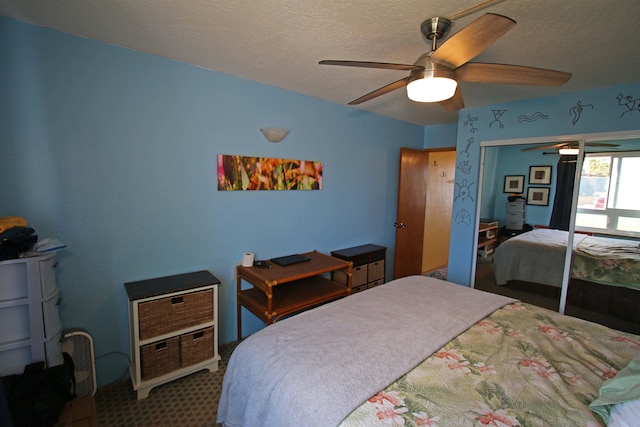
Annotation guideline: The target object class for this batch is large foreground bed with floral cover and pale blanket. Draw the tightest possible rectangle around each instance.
[218,276,640,427]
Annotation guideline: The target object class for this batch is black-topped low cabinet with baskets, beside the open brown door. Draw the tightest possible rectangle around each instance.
[331,244,387,293]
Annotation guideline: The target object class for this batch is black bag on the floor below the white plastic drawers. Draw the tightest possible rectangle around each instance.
[2,353,75,427]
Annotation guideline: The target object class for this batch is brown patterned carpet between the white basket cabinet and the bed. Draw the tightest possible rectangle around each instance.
[95,342,238,427]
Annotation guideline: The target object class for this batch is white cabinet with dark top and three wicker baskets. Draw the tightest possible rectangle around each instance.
[125,271,220,399]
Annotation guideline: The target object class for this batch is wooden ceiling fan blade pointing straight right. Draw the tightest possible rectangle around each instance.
[456,62,571,86]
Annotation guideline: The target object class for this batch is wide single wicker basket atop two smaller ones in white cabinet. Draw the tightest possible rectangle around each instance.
[138,289,213,340]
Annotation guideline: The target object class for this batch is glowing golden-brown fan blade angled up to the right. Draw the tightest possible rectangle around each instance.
[431,13,516,69]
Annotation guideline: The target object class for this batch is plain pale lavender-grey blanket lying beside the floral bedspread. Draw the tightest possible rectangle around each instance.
[218,276,513,427]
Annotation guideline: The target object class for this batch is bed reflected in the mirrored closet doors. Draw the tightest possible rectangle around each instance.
[493,228,640,334]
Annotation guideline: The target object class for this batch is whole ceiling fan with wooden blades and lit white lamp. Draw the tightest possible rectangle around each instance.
[320,13,571,111]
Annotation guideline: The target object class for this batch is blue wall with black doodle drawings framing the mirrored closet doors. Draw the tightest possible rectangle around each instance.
[448,83,640,286]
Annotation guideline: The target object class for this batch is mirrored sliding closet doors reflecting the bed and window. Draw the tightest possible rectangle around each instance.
[474,139,640,333]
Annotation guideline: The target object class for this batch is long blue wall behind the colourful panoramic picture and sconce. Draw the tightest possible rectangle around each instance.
[0,18,424,385]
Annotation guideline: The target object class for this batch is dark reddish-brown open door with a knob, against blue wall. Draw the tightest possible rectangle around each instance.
[393,148,429,278]
